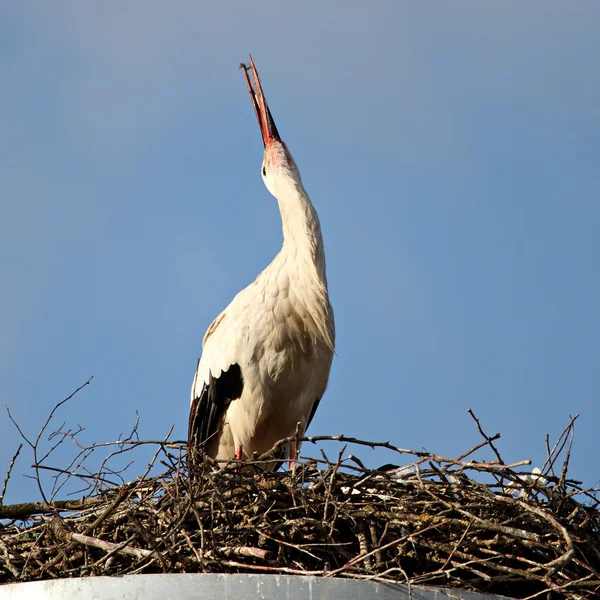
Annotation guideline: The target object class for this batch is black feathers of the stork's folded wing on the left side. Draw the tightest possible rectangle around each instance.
[188,364,244,454]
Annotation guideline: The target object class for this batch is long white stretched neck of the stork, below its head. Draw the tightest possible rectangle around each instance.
[277,183,327,288]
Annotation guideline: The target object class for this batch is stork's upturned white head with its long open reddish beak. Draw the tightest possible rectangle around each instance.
[240,57,302,198]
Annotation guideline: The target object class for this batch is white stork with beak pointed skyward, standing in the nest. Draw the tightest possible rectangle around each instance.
[188,57,335,468]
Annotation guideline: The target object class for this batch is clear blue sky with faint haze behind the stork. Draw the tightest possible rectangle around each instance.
[0,0,600,502]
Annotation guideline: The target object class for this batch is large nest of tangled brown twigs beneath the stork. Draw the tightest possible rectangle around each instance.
[0,384,600,598]
